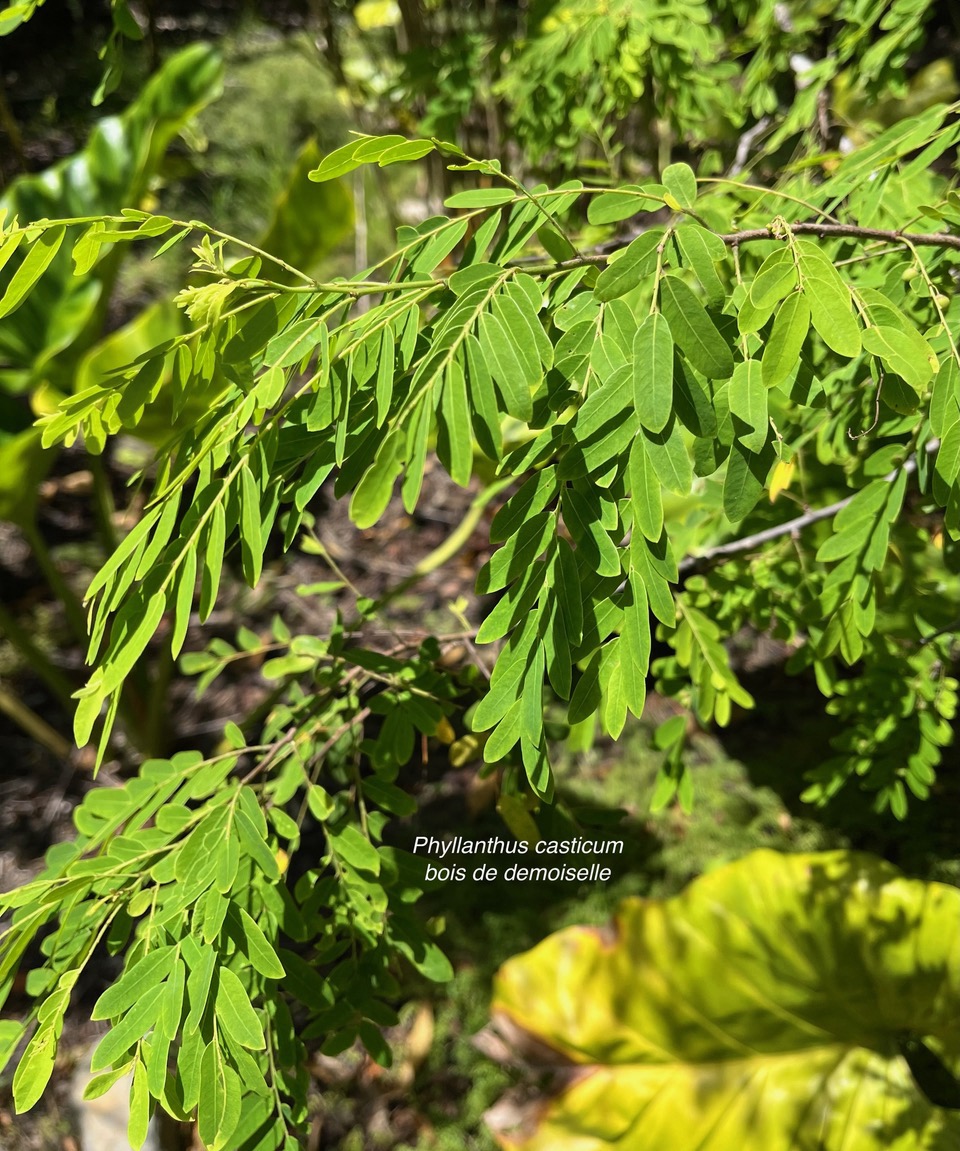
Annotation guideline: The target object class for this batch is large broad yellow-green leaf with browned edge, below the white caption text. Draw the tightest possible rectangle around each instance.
[485,851,960,1151]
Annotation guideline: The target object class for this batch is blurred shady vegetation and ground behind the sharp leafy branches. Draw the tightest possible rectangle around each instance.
[0,0,960,1151]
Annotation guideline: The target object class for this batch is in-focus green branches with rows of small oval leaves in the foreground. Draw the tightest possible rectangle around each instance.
[0,5,960,1149]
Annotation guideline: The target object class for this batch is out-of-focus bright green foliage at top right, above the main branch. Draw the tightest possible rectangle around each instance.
[358,0,957,180]
